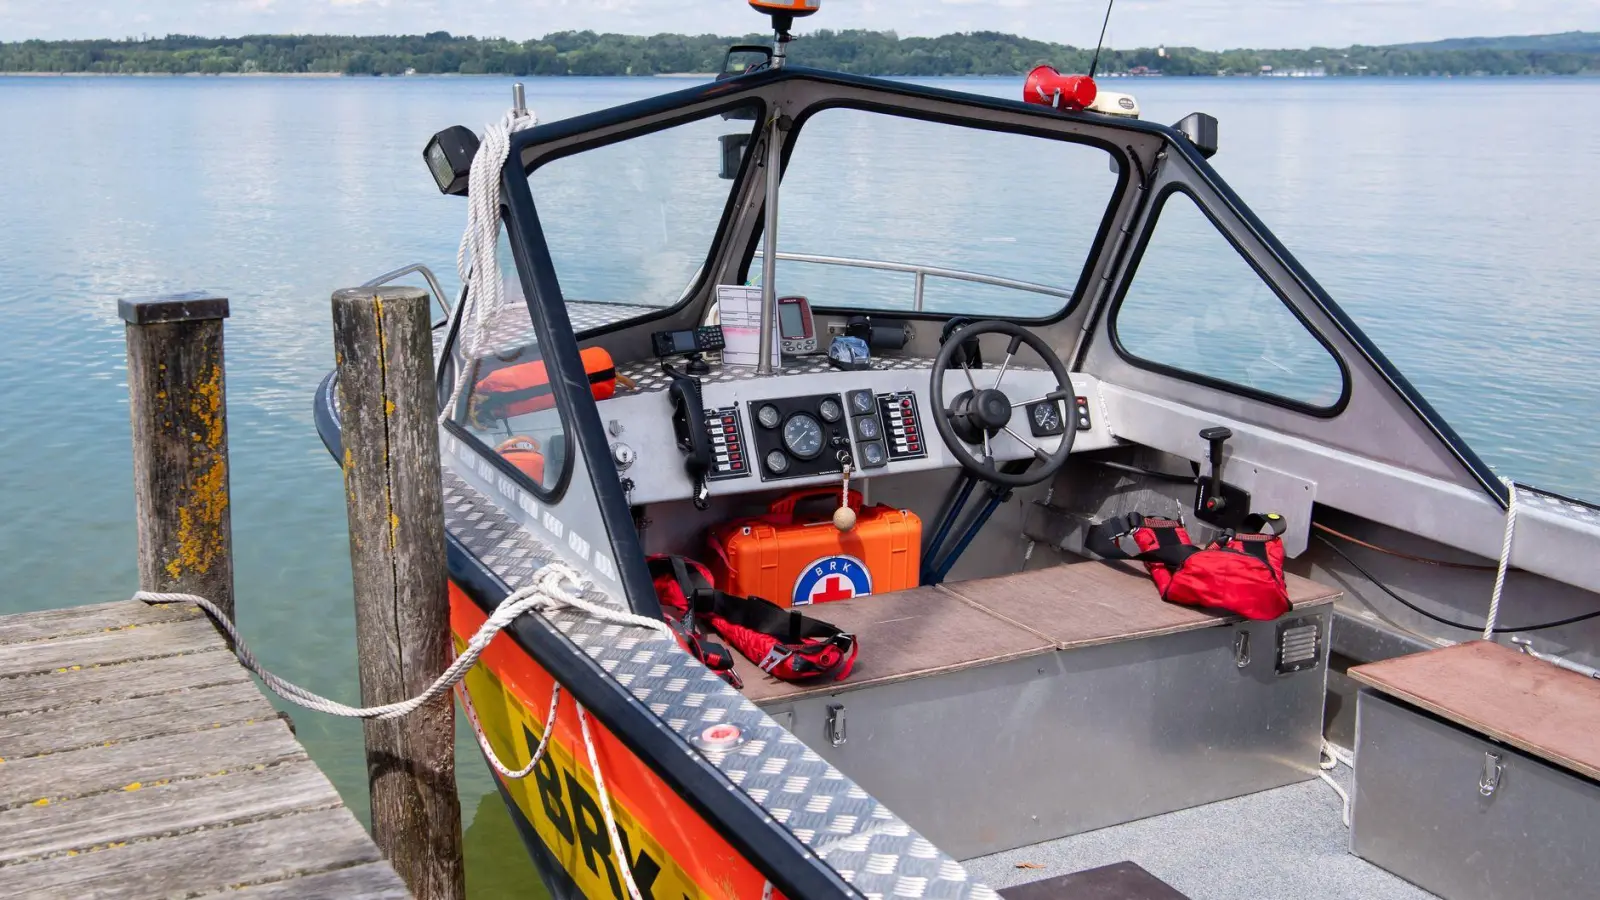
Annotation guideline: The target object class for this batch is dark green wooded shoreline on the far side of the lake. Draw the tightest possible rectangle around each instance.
[0,30,1600,75]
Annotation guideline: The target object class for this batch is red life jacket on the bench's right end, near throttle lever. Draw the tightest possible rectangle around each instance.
[1083,512,1290,620]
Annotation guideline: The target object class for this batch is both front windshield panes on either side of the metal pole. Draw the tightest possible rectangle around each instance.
[528,91,1118,320]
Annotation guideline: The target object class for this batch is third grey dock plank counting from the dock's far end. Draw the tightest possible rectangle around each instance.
[0,650,251,714]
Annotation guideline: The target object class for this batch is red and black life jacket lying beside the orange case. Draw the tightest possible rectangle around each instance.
[648,556,858,687]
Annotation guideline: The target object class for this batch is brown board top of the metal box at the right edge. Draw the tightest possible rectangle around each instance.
[1350,641,1600,780]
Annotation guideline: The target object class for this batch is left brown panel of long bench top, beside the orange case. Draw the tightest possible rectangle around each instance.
[733,588,1053,703]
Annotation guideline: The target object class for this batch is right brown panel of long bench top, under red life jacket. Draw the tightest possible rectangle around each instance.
[941,560,1341,650]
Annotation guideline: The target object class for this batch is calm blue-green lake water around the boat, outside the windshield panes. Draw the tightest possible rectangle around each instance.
[0,77,1600,897]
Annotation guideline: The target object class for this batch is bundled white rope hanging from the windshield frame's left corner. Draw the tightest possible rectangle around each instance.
[438,109,539,423]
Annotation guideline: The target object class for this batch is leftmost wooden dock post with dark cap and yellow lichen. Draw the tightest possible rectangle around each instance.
[117,293,234,618]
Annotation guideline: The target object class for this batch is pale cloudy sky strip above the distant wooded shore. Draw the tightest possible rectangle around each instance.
[0,0,1600,50]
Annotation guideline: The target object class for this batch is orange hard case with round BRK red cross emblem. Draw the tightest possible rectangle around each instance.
[710,487,922,607]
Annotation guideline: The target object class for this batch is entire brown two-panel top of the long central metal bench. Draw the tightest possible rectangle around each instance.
[734,560,1339,703]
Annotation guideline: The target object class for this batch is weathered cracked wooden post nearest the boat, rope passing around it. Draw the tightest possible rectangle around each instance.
[333,287,466,900]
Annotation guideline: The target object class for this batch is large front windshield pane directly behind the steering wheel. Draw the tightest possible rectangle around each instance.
[768,107,1117,319]
